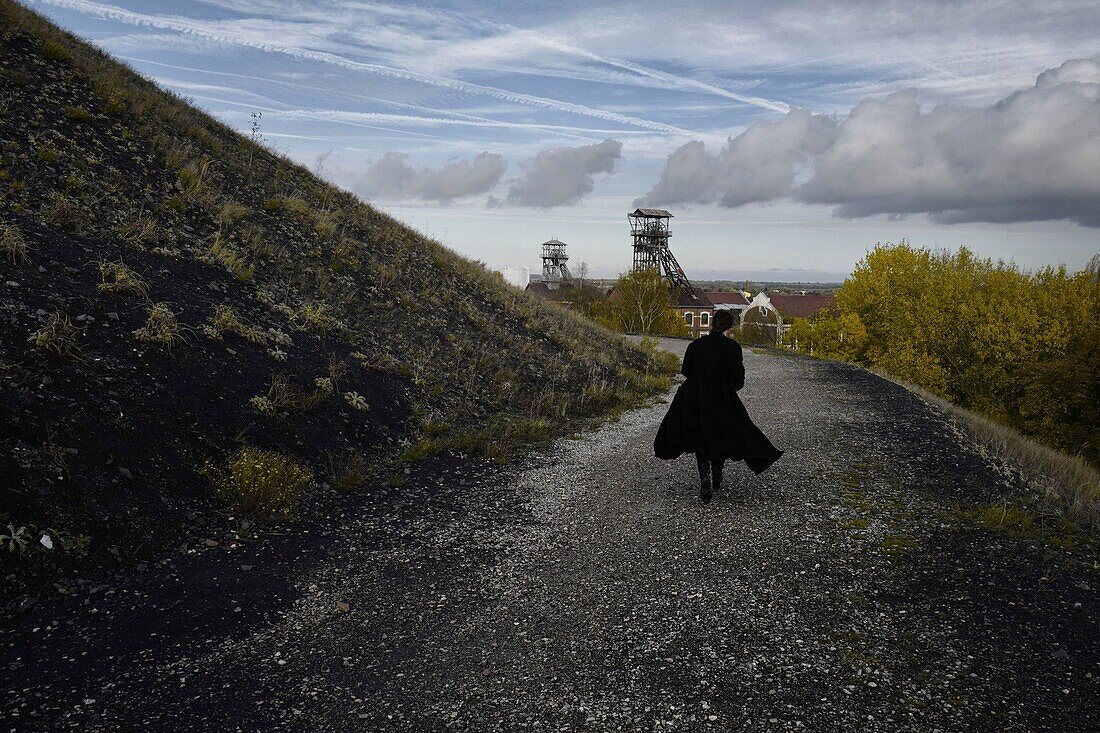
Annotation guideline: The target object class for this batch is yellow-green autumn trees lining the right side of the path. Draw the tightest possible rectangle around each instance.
[783,241,1100,466]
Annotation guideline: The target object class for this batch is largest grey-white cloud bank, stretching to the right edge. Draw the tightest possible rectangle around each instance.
[644,59,1100,227]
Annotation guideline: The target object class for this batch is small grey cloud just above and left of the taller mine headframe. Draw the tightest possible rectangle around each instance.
[507,139,623,208]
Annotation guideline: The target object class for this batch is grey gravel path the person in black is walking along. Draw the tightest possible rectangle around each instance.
[12,343,1100,732]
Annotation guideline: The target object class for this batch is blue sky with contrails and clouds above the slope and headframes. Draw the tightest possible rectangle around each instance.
[25,0,1100,281]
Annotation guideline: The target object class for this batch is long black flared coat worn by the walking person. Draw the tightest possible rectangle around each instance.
[653,333,783,473]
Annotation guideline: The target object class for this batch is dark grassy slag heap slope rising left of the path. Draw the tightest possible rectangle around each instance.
[0,0,670,581]
